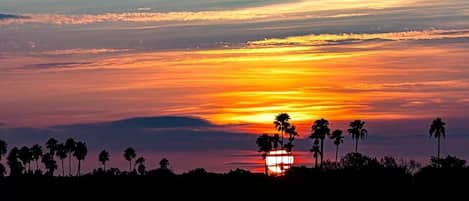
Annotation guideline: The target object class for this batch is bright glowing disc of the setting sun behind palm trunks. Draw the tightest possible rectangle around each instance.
[265,149,294,174]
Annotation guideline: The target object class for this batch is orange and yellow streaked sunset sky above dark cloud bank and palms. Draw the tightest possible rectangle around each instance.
[0,0,469,173]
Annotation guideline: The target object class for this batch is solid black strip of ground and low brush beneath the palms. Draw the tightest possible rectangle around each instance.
[0,167,469,200]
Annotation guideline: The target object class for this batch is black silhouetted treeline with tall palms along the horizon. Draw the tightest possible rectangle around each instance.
[0,113,469,198]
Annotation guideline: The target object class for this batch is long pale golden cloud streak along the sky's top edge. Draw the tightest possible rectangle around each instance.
[0,0,405,25]
